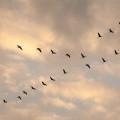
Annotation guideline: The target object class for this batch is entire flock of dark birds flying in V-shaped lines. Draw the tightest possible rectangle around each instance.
[3,22,120,103]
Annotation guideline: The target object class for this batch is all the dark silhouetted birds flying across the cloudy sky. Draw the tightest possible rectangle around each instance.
[3,22,120,103]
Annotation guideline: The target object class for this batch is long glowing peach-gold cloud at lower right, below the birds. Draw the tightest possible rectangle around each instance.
[43,80,119,104]
